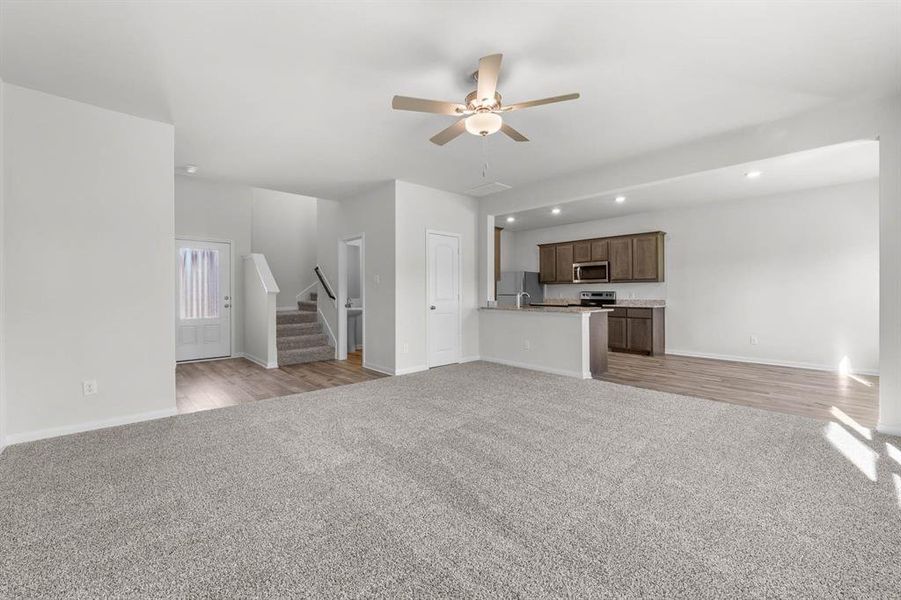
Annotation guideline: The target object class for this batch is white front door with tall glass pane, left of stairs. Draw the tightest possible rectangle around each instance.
[175,240,232,360]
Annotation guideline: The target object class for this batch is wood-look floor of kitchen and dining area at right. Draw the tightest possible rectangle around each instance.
[599,352,879,427]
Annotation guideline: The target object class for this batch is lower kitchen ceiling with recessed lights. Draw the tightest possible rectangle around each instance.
[495,140,879,231]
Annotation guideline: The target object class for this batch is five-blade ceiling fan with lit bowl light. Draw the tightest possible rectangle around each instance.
[391,54,579,146]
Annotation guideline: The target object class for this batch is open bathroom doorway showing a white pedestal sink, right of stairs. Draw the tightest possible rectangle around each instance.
[336,234,366,365]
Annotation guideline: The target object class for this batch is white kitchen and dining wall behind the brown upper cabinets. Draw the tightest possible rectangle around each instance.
[506,181,879,373]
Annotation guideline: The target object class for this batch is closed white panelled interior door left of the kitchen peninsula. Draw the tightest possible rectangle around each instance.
[427,232,460,367]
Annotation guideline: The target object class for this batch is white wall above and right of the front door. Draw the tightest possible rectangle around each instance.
[175,175,253,355]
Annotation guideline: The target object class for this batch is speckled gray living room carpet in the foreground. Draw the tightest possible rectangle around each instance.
[0,363,901,599]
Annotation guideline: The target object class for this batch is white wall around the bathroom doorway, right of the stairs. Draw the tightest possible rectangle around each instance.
[316,181,395,373]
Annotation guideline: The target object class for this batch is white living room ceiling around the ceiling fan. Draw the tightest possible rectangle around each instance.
[0,0,901,197]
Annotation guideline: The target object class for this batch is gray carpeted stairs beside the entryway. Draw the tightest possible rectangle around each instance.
[276,292,335,367]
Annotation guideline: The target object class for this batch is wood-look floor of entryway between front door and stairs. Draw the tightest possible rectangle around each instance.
[175,352,385,414]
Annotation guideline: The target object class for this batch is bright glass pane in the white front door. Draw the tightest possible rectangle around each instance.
[178,248,219,320]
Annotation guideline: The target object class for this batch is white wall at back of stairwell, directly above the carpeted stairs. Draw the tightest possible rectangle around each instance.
[251,188,316,309]
